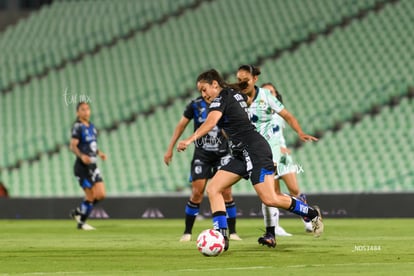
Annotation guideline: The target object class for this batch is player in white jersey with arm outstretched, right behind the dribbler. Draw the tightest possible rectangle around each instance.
[237,65,316,247]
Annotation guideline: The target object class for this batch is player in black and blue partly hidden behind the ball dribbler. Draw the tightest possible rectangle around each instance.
[164,96,241,242]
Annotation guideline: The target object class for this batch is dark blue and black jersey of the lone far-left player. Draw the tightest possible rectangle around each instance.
[72,120,98,163]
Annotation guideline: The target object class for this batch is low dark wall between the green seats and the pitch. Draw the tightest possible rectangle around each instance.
[0,193,414,219]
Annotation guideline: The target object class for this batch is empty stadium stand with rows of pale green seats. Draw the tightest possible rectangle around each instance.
[0,0,414,197]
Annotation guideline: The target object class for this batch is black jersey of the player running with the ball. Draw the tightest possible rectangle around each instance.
[209,88,256,143]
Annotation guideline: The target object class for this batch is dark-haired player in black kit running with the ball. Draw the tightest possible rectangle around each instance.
[177,69,323,250]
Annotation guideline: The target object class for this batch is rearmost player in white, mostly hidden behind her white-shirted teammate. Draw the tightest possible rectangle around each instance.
[262,82,312,235]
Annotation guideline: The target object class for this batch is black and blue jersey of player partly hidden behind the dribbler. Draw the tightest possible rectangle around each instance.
[183,96,228,153]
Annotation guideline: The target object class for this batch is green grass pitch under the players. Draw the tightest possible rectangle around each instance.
[0,219,414,275]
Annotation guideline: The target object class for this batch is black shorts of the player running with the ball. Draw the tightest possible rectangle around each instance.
[221,134,275,185]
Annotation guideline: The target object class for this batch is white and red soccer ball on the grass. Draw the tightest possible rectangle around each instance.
[197,229,225,257]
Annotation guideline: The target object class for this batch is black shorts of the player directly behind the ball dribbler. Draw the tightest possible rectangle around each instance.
[190,149,231,181]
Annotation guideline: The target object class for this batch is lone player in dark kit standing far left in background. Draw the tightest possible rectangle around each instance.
[69,102,106,230]
